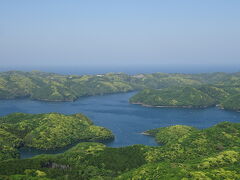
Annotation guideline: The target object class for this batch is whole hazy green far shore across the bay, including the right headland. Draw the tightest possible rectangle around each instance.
[0,71,240,111]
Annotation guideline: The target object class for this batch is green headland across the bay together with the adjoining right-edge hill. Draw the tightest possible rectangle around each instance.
[129,85,240,111]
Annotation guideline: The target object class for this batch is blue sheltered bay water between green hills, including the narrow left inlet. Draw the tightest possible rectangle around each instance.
[0,92,240,158]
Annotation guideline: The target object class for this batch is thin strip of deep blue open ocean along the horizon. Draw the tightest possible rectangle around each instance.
[0,65,240,75]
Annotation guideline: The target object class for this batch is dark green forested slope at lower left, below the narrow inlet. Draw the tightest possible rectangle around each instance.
[0,143,147,179]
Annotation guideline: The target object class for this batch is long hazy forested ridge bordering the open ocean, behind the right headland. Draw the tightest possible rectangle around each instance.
[0,71,240,101]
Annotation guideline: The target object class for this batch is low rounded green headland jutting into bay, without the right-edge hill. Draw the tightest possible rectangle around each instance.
[130,87,215,107]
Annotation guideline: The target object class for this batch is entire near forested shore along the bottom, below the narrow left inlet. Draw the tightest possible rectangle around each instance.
[0,122,240,180]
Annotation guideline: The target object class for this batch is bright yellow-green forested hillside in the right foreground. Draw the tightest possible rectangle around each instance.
[116,122,240,180]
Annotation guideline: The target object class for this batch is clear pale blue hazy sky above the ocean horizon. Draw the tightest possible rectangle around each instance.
[0,0,240,71]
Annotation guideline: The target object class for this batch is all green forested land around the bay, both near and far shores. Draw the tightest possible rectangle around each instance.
[0,71,240,180]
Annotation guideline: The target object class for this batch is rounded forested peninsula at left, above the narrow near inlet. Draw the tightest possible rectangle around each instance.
[0,113,114,160]
